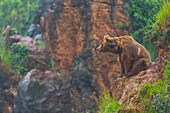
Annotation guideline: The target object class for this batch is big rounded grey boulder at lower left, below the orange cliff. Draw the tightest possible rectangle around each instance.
[14,70,71,113]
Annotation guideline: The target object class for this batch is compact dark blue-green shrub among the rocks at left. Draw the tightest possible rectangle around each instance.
[11,44,29,74]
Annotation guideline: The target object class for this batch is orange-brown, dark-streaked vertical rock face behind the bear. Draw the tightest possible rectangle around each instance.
[40,0,129,88]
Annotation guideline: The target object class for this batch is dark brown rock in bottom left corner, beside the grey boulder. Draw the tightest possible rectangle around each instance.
[0,61,17,113]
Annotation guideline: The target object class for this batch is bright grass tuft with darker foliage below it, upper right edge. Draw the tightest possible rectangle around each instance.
[145,1,170,46]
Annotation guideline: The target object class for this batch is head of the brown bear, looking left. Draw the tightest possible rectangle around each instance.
[96,35,122,54]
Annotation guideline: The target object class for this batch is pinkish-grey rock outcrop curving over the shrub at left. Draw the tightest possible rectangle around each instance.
[7,35,51,71]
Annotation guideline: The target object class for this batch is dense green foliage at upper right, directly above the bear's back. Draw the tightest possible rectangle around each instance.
[126,0,163,42]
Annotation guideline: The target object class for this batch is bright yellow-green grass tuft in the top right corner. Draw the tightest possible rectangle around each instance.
[156,1,170,26]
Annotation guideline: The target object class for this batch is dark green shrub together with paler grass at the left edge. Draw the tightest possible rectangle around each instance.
[0,30,29,74]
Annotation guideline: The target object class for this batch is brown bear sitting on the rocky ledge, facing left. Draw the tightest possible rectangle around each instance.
[96,35,151,76]
